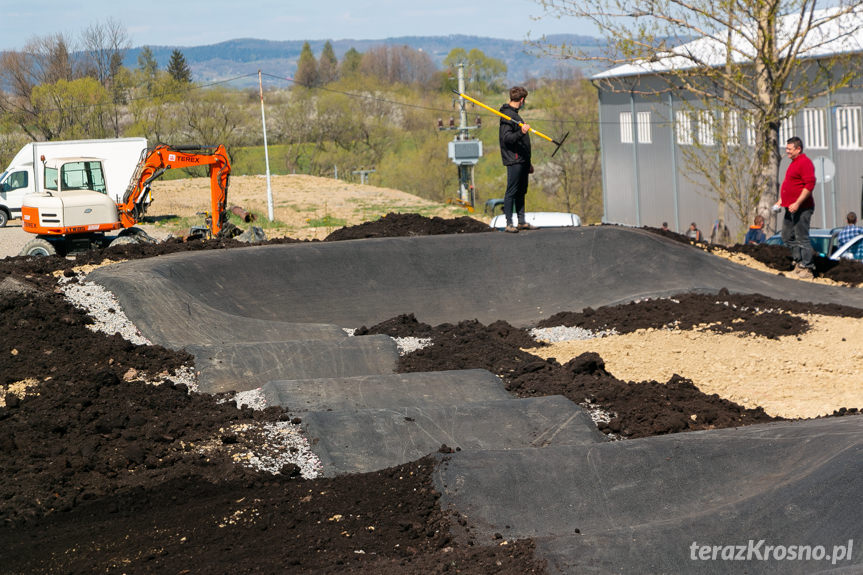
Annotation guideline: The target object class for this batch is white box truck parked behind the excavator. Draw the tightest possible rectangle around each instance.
[0,138,147,228]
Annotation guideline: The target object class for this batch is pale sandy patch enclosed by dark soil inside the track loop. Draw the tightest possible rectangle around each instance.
[530,315,863,418]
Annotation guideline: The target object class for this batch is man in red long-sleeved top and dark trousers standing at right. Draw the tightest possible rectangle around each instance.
[774,136,815,278]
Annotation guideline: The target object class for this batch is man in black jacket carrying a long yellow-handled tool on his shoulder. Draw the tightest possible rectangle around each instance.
[500,86,536,233]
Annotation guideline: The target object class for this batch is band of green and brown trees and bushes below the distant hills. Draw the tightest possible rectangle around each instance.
[0,20,602,221]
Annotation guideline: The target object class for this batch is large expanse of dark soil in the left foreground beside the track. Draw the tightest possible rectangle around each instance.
[0,280,543,575]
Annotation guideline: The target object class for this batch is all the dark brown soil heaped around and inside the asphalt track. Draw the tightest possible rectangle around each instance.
[0,214,863,574]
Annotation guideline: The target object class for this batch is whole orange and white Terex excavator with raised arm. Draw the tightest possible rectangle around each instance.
[20,144,232,256]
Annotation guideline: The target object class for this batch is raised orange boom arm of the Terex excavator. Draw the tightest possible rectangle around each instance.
[117,144,231,236]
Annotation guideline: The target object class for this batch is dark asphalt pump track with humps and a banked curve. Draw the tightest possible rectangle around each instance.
[89,226,863,573]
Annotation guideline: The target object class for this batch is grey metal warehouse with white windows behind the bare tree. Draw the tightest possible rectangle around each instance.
[592,13,863,237]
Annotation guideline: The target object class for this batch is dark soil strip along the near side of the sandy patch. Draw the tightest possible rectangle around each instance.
[357,312,784,438]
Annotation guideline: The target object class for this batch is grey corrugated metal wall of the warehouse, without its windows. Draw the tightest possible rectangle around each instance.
[597,77,863,237]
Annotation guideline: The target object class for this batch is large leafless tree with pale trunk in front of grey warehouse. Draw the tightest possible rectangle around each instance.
[537,0,863,224]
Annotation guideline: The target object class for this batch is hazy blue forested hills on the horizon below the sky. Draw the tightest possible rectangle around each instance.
[124,34,604,86]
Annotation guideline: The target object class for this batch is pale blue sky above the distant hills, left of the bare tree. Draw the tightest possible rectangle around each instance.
[0,0,595,50]
